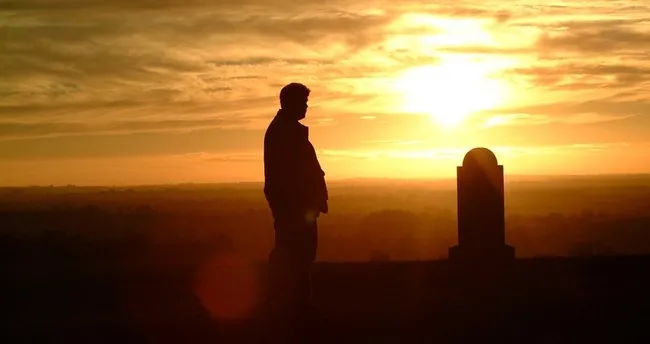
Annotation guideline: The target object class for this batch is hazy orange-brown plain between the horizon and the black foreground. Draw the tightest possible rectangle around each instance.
[5,175,650,262]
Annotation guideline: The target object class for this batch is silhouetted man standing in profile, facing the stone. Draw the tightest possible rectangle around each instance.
[264,83,328,322]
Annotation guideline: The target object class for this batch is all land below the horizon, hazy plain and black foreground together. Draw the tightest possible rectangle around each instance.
[0,175,650,343]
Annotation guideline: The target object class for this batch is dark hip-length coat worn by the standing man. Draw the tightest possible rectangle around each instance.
[264,110,328,213]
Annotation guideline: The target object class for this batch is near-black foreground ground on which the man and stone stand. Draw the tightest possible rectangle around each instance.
[3,255,650,344]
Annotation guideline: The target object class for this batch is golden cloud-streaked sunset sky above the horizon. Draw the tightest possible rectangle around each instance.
[0,0,650,185]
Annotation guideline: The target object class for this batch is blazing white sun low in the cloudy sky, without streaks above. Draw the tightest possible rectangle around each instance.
[393,58,509,127]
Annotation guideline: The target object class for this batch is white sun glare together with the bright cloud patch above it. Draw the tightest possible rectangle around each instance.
[393,14,511,127]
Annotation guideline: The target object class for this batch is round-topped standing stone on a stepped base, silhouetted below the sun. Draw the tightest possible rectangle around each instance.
[449,148,515,262]
